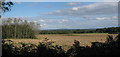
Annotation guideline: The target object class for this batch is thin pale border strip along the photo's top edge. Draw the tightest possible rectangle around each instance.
[2,0,120,2]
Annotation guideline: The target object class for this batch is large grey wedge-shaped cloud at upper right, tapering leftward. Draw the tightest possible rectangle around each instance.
[44,2,118,16]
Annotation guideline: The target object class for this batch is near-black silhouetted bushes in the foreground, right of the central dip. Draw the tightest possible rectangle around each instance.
[67,34,120,57]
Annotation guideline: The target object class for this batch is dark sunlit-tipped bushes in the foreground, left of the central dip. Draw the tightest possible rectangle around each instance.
[2,38,68,57]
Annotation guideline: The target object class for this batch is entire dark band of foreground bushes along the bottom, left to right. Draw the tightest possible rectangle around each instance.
[2,34,120,57]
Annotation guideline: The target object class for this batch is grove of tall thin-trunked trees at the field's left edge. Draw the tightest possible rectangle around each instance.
[2,18,40,39]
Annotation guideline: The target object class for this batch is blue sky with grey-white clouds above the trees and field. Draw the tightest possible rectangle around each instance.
[2,2,118,29]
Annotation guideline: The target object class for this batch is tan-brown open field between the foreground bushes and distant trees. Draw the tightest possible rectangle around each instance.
[6,33,117,49]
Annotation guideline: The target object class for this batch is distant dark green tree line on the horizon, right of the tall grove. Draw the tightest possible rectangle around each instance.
[39,27,120,34]
